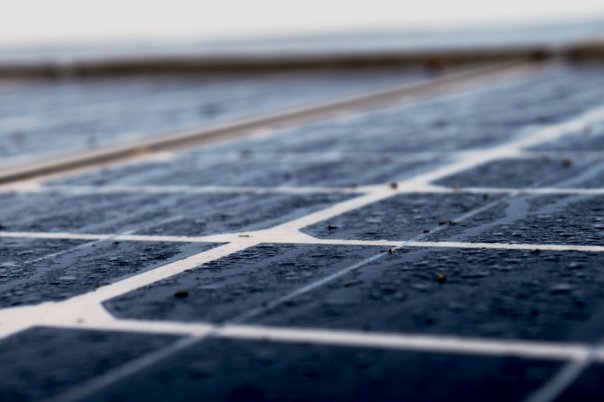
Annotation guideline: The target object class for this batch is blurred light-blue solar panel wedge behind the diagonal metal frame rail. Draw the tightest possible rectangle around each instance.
[0,69,431,164]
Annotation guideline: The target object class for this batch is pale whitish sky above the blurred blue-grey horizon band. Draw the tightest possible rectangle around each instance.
[0,0,604,44]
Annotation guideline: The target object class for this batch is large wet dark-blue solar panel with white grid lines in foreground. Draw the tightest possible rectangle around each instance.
[0,61,604,401]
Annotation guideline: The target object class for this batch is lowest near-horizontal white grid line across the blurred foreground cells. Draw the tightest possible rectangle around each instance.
[53,319,604,361]
